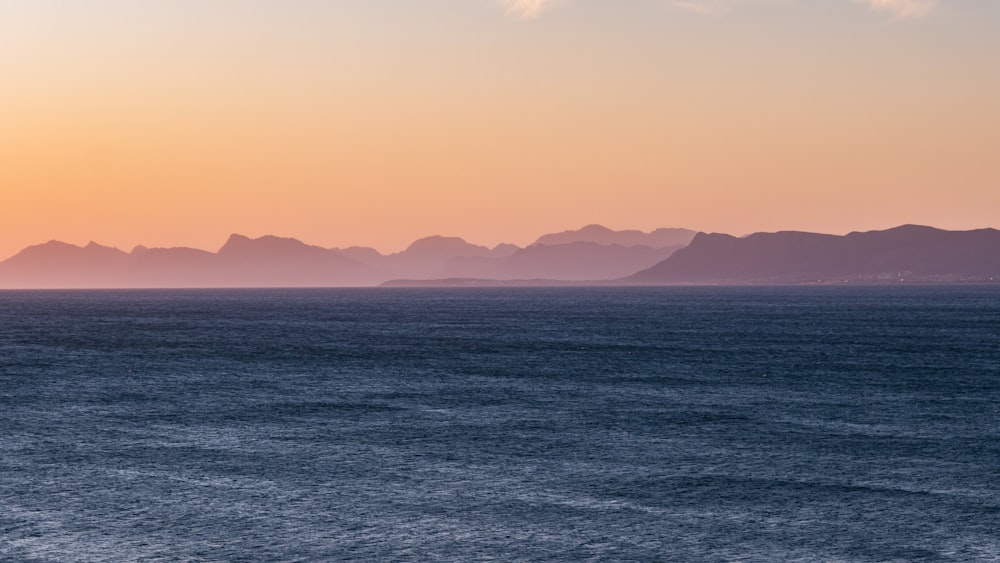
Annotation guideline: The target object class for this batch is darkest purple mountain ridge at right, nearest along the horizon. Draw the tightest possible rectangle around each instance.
[625,225,1000,284]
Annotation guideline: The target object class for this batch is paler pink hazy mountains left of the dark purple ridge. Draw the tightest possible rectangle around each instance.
[0,225,696,288]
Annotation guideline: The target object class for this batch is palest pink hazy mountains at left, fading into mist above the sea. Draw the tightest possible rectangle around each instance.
[0,234,520,288]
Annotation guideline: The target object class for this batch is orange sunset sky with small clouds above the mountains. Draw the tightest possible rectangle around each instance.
[0,0,1000,258]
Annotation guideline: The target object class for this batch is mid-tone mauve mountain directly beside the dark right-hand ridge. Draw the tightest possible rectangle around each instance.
[442,242,680,281]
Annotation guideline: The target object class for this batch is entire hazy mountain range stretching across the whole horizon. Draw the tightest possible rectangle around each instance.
[0,225,1000,288]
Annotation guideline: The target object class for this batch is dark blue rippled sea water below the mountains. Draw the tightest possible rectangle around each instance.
[0,286,1000,561]
